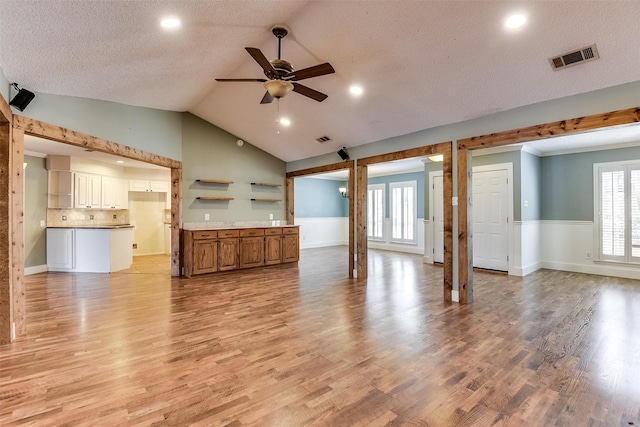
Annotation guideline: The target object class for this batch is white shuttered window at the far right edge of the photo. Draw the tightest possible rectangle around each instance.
[594,161,640,263]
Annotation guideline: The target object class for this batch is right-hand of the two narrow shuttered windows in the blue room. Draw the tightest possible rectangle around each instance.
[389,181,417,243]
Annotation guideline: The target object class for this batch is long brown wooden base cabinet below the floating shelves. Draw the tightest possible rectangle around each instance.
[183,226,300,277]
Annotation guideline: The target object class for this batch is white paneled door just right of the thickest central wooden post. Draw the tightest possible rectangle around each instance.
[473,169,509,271]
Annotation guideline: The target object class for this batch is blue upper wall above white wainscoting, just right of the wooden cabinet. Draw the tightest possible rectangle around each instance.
[293,178,349,218]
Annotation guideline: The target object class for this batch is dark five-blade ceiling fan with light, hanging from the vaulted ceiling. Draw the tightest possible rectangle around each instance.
[216,27,335,104]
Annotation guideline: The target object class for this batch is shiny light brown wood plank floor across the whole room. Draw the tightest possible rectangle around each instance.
[0,248,640,426]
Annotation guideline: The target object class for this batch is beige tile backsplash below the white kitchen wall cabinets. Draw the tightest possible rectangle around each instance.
[47,208,130,227]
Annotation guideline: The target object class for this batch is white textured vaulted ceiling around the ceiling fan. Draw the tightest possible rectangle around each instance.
[0,0,640,161]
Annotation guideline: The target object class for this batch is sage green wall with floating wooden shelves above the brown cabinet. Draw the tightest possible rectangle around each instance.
[182,113,286,222]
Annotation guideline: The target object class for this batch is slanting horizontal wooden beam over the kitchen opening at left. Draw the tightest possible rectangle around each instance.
[13,115,182,169]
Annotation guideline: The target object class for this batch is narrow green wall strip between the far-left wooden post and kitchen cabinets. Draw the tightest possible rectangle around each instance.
[24,156,48,268]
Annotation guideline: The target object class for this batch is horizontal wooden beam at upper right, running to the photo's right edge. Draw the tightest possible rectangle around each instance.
[458,107,640,150]
